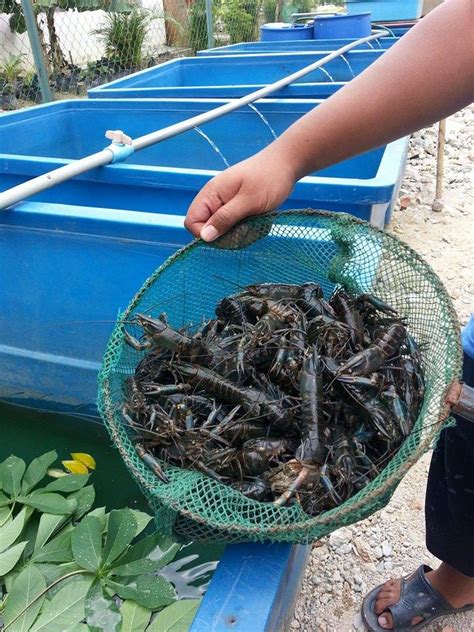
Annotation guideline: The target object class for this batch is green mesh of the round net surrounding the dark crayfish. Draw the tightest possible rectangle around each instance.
[99,210,462,543]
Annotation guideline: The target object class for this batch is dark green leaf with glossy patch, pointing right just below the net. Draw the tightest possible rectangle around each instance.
[110,533,181,576]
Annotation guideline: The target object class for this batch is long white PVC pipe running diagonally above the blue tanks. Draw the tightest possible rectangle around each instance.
[0,31,386,210]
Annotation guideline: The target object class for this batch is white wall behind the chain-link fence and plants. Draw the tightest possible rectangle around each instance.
[0,0,166,70]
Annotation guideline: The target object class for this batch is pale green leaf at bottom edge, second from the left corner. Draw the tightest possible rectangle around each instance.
[31,580,90,632]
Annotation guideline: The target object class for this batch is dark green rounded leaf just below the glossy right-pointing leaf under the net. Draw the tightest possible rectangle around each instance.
[105,575,177,610]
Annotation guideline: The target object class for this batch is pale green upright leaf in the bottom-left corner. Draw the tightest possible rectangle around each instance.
[3,564,46,632]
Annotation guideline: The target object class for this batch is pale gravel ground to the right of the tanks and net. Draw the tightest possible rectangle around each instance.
[291,108,474,632]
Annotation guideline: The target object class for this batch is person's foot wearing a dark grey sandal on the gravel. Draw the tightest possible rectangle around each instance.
[362,563,474,632]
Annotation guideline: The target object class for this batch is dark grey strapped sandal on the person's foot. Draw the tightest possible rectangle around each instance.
[362,564,474,632]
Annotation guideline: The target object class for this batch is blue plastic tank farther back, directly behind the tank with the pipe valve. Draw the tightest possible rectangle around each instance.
[88,49,384,99]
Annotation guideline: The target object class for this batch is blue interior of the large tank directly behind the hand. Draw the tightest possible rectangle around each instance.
[0,100,384,180]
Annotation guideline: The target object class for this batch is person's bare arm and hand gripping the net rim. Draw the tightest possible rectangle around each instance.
[185,0,474,241]
